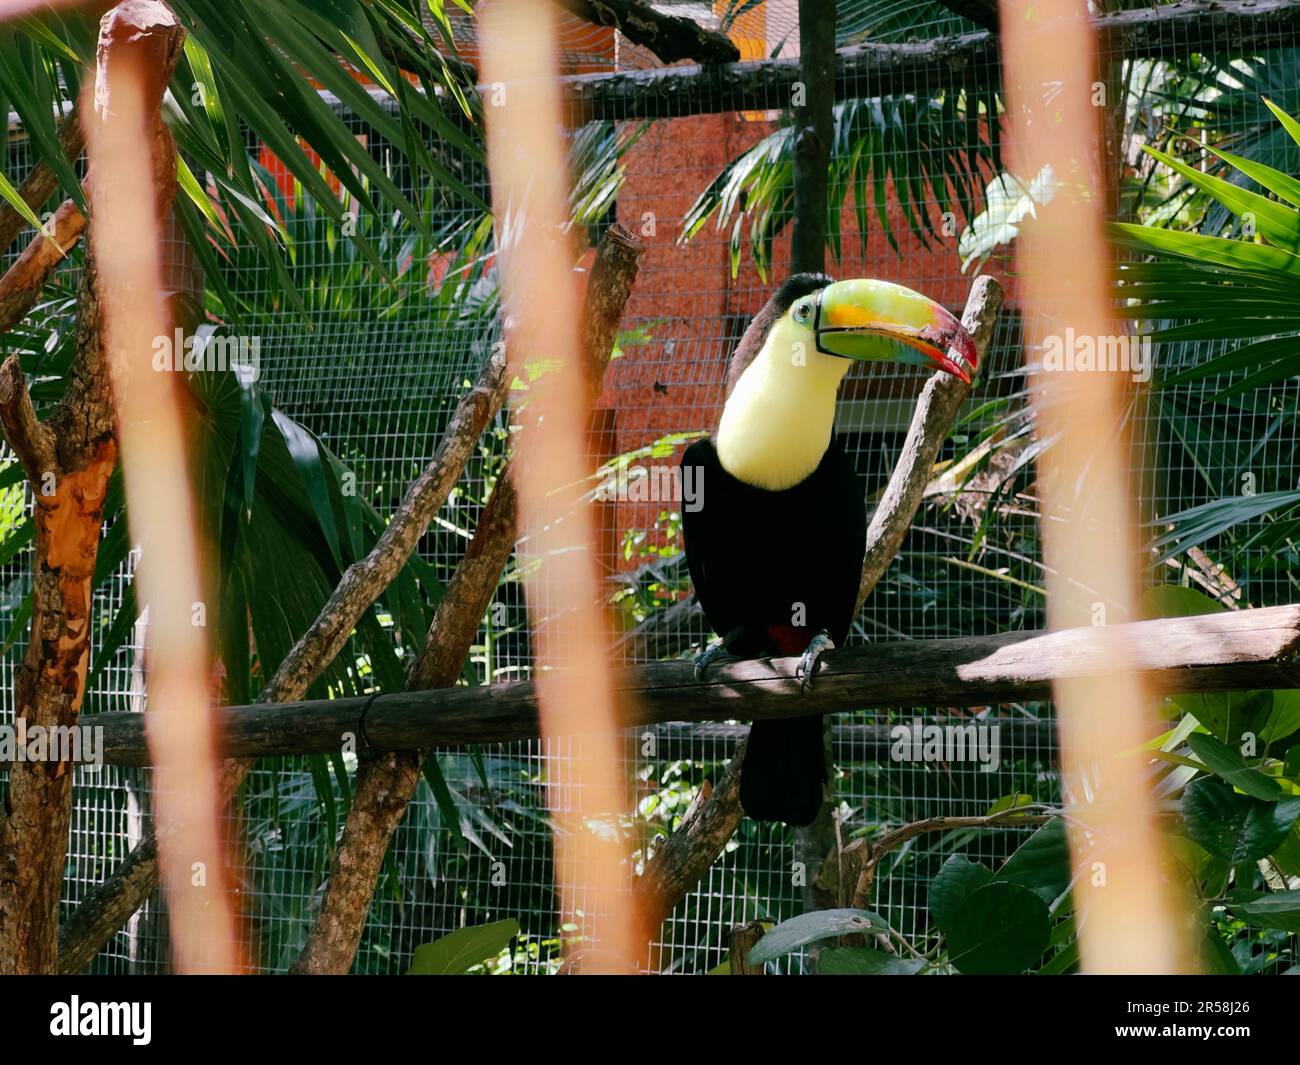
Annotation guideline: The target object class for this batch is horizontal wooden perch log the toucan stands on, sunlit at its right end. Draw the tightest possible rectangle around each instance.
[86,606,1300,766]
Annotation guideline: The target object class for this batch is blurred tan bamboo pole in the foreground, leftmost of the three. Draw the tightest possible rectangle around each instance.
[82,0,238,973]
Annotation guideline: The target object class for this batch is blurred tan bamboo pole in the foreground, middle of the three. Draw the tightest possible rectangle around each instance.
[480,0,646,973]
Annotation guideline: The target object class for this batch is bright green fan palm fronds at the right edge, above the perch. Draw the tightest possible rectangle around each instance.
[1110,100,1300,567]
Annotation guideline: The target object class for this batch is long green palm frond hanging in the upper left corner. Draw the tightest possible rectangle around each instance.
[0,0,486,300]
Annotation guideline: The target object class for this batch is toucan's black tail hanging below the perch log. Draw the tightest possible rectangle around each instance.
[740,715,826,824]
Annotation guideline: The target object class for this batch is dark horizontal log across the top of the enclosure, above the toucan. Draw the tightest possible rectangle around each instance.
[562,0,1300,121]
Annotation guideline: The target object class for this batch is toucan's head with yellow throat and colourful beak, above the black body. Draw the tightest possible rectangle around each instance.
[716,276,976,492]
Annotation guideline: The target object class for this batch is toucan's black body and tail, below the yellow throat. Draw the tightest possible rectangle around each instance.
[681,440,867,824]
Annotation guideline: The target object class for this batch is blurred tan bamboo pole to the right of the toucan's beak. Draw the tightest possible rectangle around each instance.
[1001,0,1191,973]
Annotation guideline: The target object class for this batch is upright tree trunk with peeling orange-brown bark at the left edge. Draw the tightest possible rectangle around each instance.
[0,0,183,974]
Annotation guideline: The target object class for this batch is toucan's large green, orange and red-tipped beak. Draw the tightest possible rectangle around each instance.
[814,277,979,385]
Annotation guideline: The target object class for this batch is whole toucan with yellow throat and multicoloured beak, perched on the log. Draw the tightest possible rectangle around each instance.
[681,273,978,826]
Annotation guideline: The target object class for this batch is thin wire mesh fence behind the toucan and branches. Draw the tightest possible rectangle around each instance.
[0,0,1300,973]
